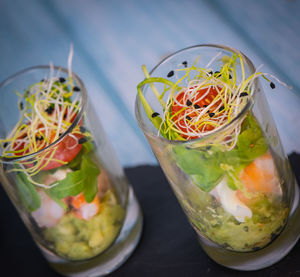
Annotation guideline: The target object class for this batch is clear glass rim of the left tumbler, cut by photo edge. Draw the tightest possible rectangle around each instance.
[0,65,87,164]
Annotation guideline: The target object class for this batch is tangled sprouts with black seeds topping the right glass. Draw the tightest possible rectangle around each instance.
[137,52,285,150]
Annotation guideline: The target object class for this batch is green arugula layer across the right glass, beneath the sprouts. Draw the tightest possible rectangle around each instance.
[174,114,268,192]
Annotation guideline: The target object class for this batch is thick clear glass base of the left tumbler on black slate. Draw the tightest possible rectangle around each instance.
[39,187,143,277]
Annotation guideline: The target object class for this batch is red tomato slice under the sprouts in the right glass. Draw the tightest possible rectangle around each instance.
[171,87,221,140]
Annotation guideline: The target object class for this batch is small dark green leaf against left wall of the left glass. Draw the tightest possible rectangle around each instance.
[16,172,41,212]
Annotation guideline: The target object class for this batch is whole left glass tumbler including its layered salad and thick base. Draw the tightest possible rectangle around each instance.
[0,66,142,276]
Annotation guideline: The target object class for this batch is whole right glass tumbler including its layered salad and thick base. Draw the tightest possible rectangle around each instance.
[135,45,300,270]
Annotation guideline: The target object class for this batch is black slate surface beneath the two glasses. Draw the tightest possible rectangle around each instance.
[0,154,300,277]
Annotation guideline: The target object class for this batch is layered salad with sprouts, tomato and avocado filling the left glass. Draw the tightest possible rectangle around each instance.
[0,69,125,260]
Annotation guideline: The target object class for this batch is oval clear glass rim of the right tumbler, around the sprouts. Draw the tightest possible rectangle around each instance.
[135,44,258,145]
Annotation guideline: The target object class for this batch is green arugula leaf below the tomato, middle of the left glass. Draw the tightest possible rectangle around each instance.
[50,153,100,202]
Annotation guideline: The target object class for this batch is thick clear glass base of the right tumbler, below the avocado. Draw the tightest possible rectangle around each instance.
[199,181,300,271]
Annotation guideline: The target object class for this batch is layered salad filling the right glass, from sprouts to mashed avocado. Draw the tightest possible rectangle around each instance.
[137,53,289,252]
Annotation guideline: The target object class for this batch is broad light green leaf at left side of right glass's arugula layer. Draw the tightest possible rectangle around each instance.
[174,146,224,191]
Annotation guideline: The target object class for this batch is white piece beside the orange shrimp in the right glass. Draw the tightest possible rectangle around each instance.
[211,178,252,222]
